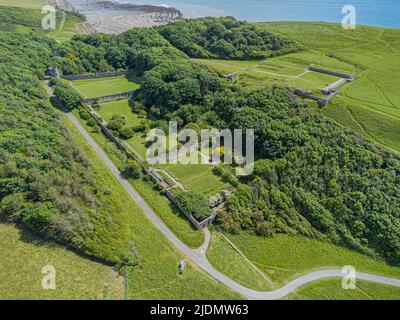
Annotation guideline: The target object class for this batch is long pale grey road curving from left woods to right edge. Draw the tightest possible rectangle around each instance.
[47,84,400,300]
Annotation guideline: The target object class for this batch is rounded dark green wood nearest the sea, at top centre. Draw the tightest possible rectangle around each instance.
[159,17,296,59]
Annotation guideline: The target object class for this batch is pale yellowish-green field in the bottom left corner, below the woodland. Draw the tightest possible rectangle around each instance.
[0,222,124,300]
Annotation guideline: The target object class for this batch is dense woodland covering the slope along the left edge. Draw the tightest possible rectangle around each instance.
[0,33,100,250]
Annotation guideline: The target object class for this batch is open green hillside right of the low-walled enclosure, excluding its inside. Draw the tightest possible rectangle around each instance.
[258,22,400,151]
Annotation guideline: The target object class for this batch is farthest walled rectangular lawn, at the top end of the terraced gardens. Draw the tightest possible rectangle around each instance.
[70,76,139,98]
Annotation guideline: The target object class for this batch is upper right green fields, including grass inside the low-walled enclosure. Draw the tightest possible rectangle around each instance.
[200,22,400,151]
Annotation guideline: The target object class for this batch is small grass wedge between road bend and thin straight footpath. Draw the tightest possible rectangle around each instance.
[207,232,272,291]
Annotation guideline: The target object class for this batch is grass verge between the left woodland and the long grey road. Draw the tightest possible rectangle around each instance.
[64,109,240,299]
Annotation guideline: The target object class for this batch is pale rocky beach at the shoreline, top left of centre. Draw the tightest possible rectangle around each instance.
[54,0,183,33]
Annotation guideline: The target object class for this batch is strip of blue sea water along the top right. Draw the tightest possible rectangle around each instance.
[118,0,400,28]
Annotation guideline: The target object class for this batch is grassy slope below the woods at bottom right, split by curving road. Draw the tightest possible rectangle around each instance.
[207,232,400,300]
